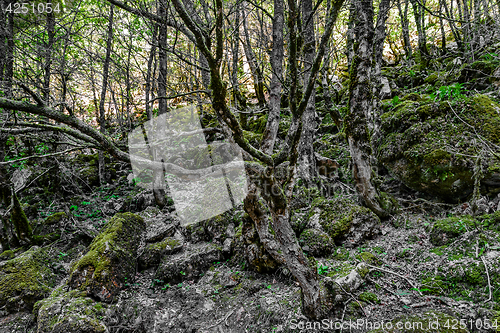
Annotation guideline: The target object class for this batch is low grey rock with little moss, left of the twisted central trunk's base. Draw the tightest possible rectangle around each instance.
[155,243,223,284]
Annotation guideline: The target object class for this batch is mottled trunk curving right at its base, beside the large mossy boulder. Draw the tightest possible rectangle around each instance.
[345,0,388,217]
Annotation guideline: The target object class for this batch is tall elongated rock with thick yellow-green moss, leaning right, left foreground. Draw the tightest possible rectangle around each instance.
[69,213,146,302]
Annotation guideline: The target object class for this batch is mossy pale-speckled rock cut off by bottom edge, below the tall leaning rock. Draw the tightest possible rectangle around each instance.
[33,287,109,333]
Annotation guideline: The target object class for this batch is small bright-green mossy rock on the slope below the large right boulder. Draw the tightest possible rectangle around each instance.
[429,215,476,246]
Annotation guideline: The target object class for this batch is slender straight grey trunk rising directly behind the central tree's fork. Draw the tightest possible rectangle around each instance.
[261,0,285,154]
